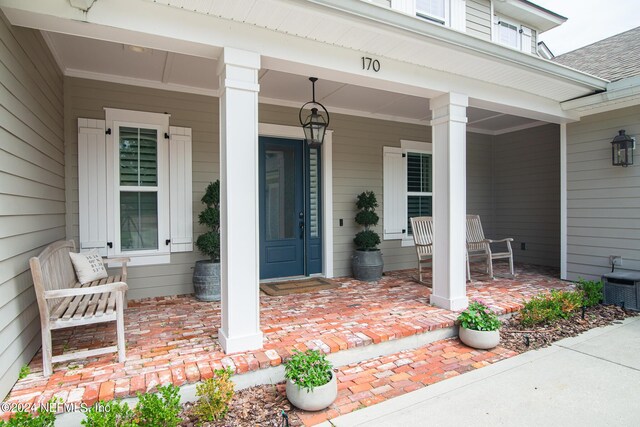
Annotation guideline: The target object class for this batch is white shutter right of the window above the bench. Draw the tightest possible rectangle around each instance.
[169,126,193,252]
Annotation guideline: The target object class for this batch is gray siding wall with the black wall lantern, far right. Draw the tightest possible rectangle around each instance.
[567,106,640,280]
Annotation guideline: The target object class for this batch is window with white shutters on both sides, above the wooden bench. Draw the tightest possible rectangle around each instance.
[78,108,193,265]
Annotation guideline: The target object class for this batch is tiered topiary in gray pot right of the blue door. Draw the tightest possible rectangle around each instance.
[351,191,384,282]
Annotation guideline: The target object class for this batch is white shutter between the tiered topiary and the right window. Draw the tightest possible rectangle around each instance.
[382,147,407,240]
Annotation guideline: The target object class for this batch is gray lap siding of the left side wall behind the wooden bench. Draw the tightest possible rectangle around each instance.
[0,13,65,398]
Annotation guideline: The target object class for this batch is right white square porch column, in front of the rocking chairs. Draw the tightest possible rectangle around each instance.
[431,93,468,310]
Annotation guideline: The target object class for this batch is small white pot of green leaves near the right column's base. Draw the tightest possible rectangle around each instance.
[458,301,500,350]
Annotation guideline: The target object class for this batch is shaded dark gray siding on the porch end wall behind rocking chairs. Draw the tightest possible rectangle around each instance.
[487,125,560,267]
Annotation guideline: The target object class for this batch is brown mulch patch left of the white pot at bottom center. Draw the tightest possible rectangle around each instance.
[180,383,302,427]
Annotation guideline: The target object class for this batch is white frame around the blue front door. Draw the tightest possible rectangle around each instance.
[258,123,333,277]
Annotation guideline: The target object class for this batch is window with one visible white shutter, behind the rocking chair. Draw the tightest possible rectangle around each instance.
[383,141,433,244]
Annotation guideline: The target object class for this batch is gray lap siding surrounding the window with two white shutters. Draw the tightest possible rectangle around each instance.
[65,77,220,299]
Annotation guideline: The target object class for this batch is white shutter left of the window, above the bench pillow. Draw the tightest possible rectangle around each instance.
[78,119,107,256]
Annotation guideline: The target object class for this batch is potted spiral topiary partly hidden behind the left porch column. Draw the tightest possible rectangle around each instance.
[193,180,220,301]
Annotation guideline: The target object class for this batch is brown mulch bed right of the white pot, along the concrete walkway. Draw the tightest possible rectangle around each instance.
[500,305,638,353]
